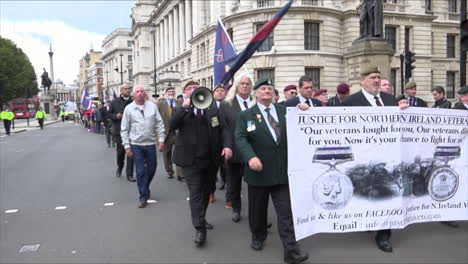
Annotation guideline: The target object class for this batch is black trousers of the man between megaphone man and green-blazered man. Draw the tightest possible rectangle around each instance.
[226,162,245,213]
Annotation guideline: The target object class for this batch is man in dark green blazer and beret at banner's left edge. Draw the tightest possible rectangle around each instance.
[235,79,308,263]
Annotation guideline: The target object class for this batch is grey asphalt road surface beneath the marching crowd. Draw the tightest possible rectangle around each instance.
[0,122,468,263]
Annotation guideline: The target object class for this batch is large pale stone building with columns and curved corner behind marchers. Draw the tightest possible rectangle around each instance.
[132,0,460,102]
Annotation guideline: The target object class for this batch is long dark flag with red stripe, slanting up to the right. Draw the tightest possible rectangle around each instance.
[221,0,294,85]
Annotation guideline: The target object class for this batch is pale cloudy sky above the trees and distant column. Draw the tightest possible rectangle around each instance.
[0,0,133,84]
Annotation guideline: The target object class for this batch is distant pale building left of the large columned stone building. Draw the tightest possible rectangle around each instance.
[101,28,134,98]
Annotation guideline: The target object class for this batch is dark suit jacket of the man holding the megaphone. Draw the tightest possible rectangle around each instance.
[169,106,231,167]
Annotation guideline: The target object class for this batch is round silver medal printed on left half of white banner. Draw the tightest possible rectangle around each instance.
[312,147,354,210]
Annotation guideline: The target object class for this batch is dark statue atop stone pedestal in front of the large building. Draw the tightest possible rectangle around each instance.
[358,0,384,39]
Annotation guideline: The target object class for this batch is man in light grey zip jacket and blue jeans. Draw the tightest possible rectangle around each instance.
[120,85,166,208]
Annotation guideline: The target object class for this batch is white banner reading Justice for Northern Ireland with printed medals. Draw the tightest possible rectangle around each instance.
[287,107,468,240]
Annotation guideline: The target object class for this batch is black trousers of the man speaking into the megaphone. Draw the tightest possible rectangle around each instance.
[183,161,216,232]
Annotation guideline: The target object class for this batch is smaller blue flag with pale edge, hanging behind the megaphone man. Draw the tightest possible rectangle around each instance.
[213,18,237,87]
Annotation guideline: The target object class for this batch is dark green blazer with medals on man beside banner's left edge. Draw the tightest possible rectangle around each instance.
[235,104,288,186]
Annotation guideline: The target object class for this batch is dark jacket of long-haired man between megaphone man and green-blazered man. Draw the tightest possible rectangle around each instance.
[219,97,242,163]
